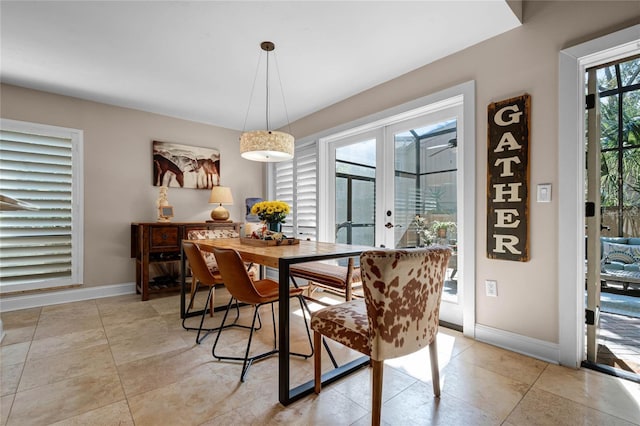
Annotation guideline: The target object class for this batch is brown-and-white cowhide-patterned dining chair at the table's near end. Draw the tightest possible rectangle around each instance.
[311,246,451,425]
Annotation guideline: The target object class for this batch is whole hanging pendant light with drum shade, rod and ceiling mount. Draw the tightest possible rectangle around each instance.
[240,41,295,163]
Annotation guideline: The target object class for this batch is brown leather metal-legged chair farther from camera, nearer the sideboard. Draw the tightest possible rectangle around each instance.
[182,241,240,344]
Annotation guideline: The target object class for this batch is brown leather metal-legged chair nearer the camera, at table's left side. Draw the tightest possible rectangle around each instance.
[211,247,313,382]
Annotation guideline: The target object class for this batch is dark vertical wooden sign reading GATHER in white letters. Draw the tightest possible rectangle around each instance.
[487,94,531,262]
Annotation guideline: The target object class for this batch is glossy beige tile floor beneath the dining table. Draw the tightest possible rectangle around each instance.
[0,295,640,426]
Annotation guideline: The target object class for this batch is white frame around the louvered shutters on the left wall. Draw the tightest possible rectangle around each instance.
[0,118,84,294]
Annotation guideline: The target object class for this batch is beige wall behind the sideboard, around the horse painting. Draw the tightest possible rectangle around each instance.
[0,85,264,287]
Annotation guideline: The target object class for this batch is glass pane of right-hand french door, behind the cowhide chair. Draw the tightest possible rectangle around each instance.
[394,119,457,300]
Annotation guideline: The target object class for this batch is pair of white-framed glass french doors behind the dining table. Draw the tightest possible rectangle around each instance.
[325,102,463,326]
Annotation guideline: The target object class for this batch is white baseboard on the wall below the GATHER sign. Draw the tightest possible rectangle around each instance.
[475,324,560,364]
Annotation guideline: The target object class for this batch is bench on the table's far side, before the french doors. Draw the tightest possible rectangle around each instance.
[289,257,362,302]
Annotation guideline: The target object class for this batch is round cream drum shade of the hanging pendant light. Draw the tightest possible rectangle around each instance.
[240,130,294,162]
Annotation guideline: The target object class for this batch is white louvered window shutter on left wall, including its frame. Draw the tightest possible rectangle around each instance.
[0,120,82,292]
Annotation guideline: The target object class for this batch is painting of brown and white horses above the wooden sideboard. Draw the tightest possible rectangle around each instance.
[152,141,220,189]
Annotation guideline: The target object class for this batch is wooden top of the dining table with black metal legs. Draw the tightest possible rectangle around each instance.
[186,238,375,268]
